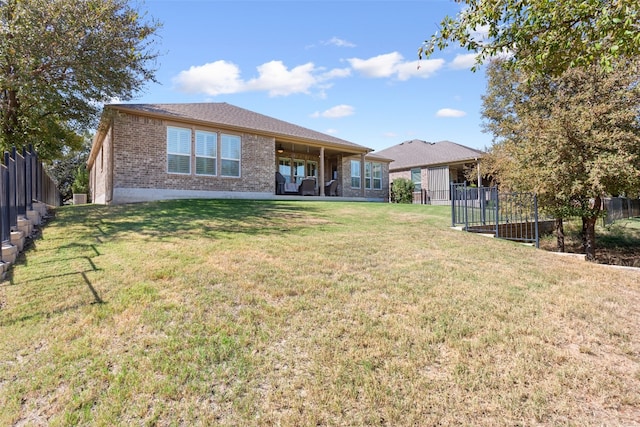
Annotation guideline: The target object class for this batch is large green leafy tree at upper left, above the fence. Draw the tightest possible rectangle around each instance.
[0,0,159,159]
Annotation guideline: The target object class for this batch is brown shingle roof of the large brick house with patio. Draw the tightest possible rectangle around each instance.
[107,102,372,152]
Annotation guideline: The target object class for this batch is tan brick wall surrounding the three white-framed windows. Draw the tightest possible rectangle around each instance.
[113,114,275,193]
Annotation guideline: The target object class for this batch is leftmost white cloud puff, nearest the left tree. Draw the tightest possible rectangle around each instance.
[173,61,243,96]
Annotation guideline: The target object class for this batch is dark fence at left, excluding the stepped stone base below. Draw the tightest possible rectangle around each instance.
[0,147,60,243]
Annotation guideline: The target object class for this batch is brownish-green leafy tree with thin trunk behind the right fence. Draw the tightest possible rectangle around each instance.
[482,58,640,260]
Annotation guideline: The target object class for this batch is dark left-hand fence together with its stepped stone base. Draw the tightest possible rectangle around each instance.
[0,147,60,263]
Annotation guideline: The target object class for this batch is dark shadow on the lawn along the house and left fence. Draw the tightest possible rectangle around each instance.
[0,199,322,325]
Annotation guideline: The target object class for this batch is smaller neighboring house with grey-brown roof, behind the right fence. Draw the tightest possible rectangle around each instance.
[377,139,484,204]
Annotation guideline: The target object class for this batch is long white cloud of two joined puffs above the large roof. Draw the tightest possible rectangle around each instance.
[173,60,351,96]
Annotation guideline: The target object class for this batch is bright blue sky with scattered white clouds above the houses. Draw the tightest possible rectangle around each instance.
[132,0,491,150]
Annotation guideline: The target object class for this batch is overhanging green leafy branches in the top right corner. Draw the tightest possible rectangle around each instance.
[419,0,640,75]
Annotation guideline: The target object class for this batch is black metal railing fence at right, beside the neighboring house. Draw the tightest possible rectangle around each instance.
[451,183,552,247]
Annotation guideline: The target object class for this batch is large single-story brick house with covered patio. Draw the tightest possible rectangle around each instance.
[87,103,390,204]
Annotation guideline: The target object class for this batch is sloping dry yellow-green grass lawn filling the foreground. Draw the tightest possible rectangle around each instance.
[0,200,640,426]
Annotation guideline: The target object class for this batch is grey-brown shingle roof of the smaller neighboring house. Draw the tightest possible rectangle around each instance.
[376,139,484,171]
